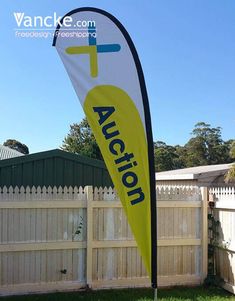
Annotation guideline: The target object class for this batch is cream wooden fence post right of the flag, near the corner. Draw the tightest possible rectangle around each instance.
[201,187,208,282]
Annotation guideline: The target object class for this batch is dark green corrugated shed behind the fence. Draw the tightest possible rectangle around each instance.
[0,149,112,187]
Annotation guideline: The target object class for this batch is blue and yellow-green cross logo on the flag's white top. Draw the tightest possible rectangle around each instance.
[65,27,121,77]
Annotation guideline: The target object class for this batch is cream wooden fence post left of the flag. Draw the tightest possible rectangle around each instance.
[85,186,93,288]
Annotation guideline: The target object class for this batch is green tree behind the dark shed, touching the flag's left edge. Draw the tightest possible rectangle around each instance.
[61,118,103,160]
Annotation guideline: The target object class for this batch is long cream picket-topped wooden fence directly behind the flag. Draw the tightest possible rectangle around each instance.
[0,186,207,294]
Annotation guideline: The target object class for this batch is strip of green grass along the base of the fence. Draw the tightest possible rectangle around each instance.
[0,287,235,301]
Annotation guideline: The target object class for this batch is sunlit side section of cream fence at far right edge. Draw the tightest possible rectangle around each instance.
[209,187,235,293]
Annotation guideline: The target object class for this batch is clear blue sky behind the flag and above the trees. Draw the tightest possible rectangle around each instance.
[0,0,235,152]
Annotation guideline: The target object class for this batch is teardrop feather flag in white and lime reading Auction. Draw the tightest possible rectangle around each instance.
[53,7,157,288]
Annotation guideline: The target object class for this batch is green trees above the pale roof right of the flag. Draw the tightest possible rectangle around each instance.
[154,122,235,171]
